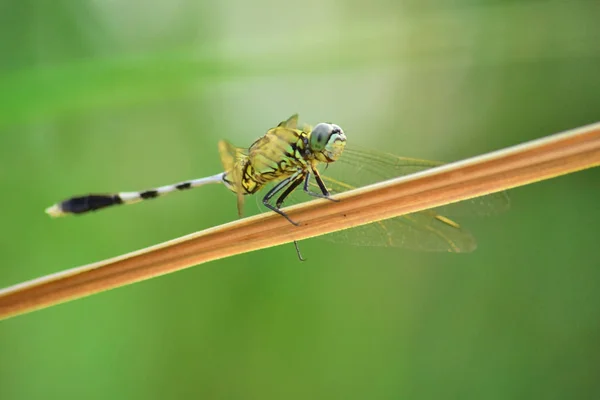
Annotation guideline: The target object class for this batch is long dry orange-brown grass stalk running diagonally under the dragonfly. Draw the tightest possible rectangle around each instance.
[0,123,600,319]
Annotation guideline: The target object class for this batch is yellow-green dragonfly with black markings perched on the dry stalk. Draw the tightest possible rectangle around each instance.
[46,114,509,260]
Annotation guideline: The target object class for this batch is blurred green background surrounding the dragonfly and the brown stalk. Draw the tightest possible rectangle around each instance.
[0,0,600,400]
